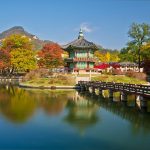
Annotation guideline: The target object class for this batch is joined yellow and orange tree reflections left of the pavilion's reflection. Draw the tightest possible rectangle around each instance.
[0,85,72,123]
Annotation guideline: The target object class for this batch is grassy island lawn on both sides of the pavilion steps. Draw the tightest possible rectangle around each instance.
[23,75,147,86]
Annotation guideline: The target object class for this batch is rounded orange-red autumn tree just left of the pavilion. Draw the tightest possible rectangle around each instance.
[38,44,63,69]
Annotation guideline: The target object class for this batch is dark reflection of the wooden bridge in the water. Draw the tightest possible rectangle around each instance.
[81,94,150,133]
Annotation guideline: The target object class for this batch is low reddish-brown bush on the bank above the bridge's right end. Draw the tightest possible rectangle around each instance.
[125,71,147,80]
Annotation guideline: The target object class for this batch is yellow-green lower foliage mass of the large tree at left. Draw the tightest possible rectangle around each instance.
[10,48,36,71]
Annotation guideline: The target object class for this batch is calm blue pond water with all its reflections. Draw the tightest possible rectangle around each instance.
[0,86,150,150]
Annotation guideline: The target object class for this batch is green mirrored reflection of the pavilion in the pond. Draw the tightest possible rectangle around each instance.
[65,92,98,132]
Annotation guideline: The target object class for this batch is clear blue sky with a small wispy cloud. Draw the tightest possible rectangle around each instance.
[0,0,150,49]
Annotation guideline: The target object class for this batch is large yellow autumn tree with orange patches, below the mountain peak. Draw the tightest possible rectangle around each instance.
[1,34,36,75]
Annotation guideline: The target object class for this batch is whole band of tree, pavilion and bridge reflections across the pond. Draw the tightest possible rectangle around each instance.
[0,85,150,134]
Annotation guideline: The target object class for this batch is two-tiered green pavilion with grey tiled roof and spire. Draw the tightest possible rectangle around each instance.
[63,29,98,72]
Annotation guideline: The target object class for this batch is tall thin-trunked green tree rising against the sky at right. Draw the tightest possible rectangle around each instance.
[128,23,150,71]
